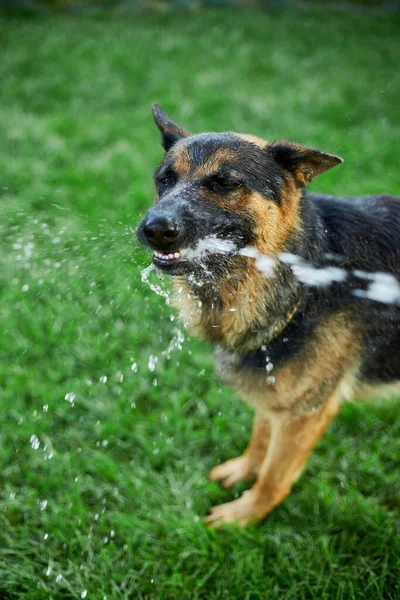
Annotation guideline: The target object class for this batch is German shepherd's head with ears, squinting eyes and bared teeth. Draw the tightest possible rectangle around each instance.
[138,104,342,275]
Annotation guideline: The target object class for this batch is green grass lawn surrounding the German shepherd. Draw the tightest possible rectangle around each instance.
[0,10,400,600]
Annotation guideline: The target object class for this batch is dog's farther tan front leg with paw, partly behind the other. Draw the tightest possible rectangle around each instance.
[209,411,270,488]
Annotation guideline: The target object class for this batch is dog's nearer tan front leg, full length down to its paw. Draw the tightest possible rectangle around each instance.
[207,393,339,527]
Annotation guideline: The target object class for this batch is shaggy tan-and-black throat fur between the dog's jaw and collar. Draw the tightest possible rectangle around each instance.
[174,258,301,352]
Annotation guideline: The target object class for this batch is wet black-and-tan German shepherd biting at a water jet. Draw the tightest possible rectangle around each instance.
[138,105,400,527]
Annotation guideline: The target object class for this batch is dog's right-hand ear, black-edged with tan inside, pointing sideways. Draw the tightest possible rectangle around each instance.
[267,140,343,187]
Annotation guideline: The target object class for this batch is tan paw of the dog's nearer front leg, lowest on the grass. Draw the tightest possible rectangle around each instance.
[206,490,272,528]
